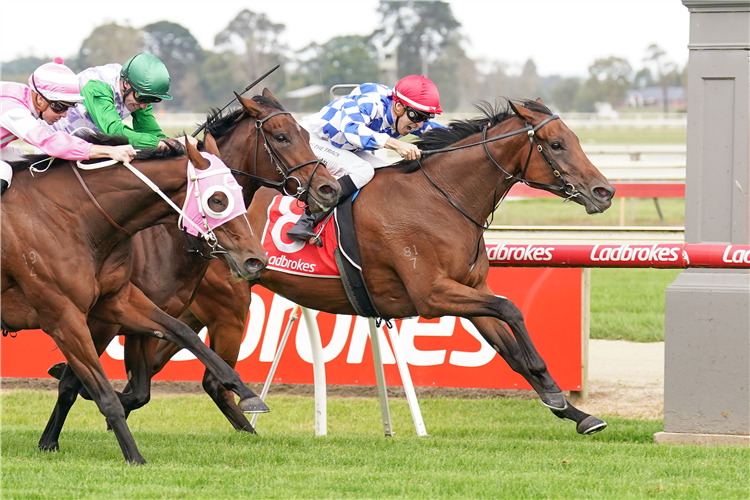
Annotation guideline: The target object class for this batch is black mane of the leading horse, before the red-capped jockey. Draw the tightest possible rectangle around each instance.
[394,99,552,174]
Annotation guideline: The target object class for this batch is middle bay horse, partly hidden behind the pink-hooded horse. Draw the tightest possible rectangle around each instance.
[39,89,340,442]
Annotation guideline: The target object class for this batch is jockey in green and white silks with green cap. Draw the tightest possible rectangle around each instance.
[53,53,197,148]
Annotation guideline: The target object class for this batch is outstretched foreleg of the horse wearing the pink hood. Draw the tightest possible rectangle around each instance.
[91,283,268,413]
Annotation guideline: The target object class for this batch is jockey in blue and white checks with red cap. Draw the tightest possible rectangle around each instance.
[286,75,443,241]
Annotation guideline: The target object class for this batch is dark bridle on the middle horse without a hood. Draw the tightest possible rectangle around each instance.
[229,111,321,208]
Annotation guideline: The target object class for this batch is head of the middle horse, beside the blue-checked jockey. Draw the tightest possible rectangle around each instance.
[208,89,341,212]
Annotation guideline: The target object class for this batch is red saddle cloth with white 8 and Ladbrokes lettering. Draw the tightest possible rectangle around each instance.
[263,195,339,278]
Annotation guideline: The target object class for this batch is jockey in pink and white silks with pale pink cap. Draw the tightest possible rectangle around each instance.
[0,58,136,194]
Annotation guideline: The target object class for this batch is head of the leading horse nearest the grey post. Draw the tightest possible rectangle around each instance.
[508,99,615,214]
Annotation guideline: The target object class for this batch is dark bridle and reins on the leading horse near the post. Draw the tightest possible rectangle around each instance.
[417,115,581,231]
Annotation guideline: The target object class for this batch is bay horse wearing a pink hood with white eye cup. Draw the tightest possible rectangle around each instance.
[0,136,268,463]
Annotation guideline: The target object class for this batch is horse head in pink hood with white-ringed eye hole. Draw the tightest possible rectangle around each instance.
[185,133,268,280]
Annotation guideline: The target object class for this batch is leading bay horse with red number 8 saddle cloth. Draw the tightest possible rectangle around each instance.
[145,100,615,434]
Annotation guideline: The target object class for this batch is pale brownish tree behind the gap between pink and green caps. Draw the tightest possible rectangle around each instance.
[76,23,145,70]
